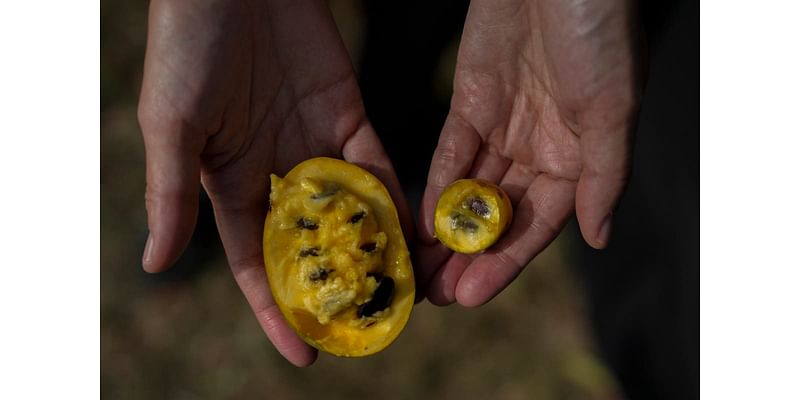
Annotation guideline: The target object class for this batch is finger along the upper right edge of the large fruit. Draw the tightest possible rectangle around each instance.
[342,122,414,245]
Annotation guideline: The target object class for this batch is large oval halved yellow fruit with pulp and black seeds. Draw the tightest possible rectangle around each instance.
[264,157,414,357]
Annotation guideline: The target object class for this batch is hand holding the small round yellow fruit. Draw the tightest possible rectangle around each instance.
[417,0,642,307]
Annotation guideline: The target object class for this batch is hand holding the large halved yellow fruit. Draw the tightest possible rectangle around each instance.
[139,0,413,366]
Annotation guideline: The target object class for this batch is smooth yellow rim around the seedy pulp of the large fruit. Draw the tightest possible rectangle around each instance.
[263,157,415,357]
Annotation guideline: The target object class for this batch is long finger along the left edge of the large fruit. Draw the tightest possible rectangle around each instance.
[203,166,317,367]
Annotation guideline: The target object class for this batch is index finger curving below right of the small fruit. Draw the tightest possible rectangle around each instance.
[455,174,575,307]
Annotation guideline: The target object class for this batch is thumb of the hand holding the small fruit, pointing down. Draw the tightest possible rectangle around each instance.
[575,122,631,249]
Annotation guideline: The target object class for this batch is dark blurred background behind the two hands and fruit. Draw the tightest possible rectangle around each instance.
[100,0,699,399]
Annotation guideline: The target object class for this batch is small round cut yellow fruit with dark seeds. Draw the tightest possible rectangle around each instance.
[434,179,513,254]
